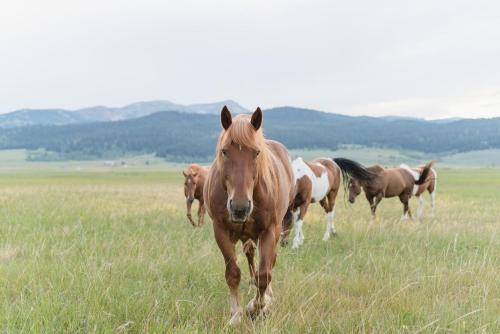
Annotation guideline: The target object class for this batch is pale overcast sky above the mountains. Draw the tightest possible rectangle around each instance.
[0,0,500,118]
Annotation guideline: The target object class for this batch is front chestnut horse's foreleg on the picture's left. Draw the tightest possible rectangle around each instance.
[214,222,242,325]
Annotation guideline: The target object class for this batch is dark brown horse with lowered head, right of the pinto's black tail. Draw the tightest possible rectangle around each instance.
[343,160,434,220]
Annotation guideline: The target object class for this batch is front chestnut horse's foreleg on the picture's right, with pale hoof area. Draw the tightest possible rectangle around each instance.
[247,227,277,319]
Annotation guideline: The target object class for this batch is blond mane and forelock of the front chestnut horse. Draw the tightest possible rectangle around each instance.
[215,114,277,194]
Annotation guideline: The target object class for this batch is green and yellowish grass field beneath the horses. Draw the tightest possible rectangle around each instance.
[0,169,500,333]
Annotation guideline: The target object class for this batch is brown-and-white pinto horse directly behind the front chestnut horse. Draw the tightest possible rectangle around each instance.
[281,157,340,249]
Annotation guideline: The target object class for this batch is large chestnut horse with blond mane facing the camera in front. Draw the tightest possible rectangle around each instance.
[203,106,294,325]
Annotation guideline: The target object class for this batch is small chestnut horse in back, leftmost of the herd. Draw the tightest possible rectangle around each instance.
[182,164,208,227]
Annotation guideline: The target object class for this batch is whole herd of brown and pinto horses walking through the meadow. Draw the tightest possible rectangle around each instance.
[183,106,437,325]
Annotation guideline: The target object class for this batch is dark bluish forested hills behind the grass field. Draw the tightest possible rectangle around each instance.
[0,107,500,160]
